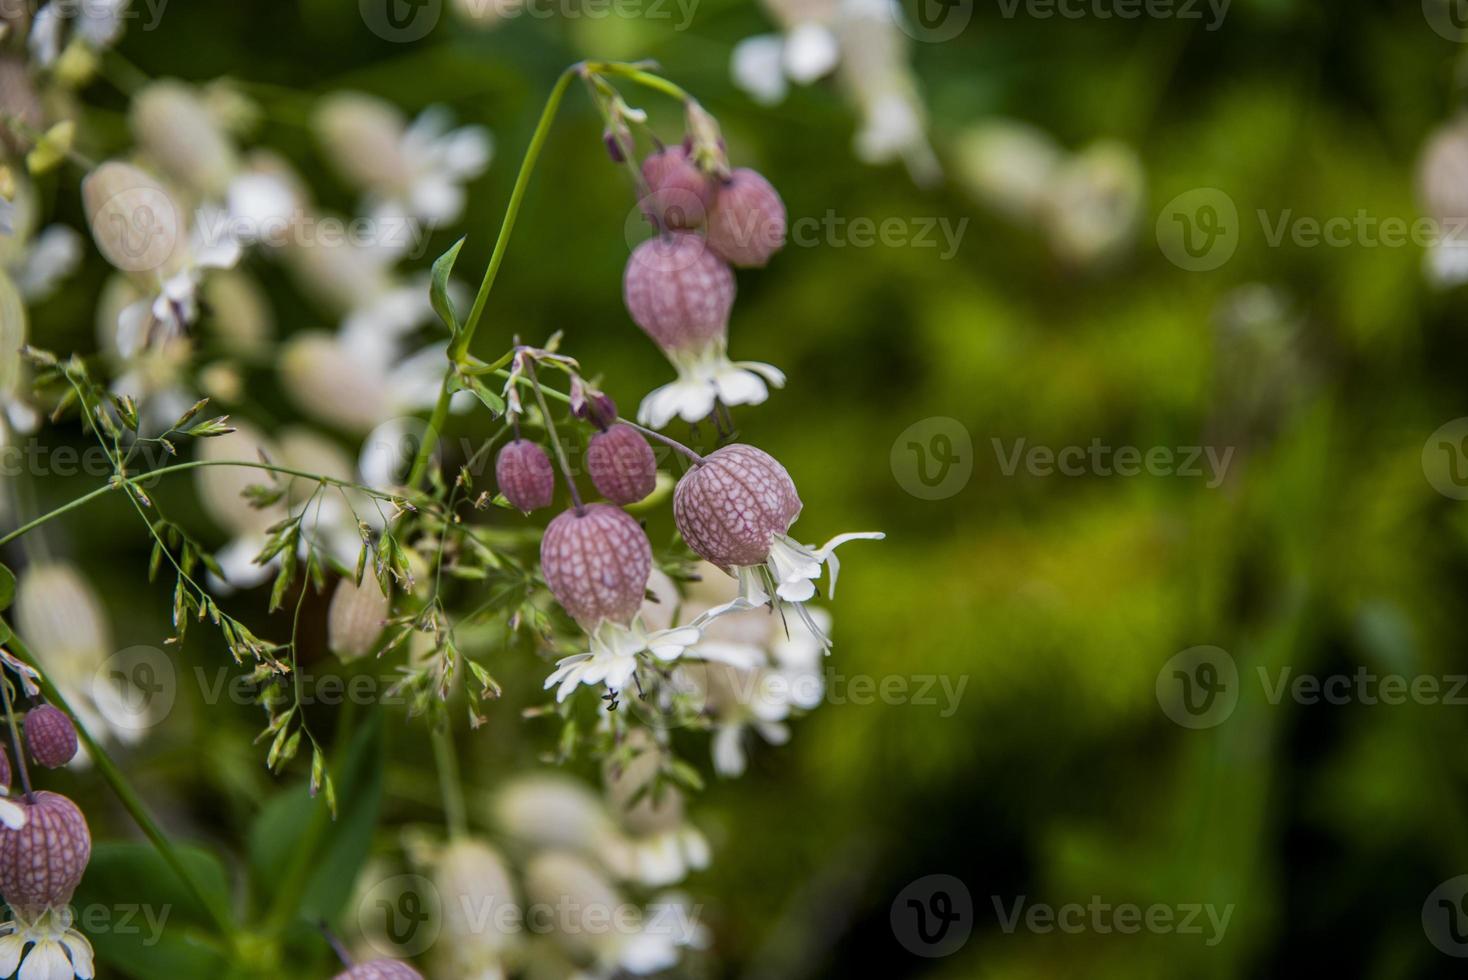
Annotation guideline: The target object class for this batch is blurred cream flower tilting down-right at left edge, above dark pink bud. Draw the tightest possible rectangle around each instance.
[15,562,148,757]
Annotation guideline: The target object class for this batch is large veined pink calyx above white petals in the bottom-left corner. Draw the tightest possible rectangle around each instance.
[0,789,91,920]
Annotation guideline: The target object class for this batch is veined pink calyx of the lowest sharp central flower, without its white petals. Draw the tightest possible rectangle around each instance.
[540,503,652,629]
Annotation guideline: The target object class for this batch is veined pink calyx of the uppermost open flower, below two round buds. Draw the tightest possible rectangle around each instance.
[622,232,734,351]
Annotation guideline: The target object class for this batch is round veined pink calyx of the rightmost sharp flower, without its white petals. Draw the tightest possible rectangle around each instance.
[672,443,800,568]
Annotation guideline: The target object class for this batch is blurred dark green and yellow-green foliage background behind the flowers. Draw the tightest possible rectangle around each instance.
[8,0,1468,979]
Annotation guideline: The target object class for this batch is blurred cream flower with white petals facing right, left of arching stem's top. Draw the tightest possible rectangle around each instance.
[316,92,493,226]
